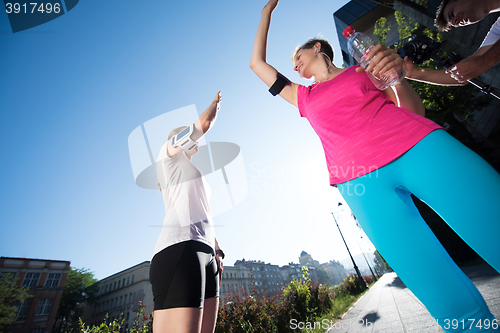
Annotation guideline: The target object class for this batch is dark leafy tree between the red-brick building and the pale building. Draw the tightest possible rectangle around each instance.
[53,267,99,332]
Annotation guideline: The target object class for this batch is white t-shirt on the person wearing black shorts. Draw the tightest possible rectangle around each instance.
[154,143,215,254]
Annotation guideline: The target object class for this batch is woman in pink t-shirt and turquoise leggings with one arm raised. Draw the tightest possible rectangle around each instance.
[250,0,500,332]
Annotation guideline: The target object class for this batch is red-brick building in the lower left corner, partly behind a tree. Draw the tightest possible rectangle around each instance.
[0,257,70,333]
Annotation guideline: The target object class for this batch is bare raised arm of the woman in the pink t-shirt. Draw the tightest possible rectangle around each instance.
[250,0,298,106]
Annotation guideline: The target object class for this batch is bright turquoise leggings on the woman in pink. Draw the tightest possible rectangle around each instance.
[338,130,500,332]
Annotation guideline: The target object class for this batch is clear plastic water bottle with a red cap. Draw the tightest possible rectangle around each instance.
[342,26,399,90]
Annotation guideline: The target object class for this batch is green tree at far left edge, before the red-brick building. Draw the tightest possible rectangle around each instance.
[0,273,33,333]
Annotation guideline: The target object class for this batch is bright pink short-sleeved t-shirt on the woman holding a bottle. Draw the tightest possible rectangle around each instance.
[297,66,442,185]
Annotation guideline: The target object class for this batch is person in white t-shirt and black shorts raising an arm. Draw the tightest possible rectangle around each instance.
[150,92,224,333]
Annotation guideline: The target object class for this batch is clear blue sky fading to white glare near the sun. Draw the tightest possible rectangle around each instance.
[0,0,373,279]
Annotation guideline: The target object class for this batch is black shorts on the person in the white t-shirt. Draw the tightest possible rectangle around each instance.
[149,241,219,310]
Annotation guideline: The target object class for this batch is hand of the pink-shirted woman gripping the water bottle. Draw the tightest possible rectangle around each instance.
[356,44,403,76]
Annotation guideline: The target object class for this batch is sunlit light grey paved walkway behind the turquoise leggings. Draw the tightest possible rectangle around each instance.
[328,265,500,333]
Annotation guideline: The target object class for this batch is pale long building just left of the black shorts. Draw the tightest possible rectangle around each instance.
[82,261,153,332]
